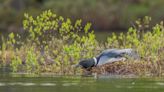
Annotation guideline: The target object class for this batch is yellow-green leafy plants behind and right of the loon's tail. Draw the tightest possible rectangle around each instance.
[106,16,164,75]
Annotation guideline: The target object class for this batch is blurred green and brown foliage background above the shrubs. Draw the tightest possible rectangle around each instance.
[0,0,164,31]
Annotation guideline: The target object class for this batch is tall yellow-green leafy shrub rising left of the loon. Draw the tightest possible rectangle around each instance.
[23,10,97,72]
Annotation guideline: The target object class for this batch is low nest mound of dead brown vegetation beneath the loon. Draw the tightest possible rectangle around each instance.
[92,60,164,76]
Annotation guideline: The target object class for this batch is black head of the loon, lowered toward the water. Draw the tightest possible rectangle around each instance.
[76,58,95,69]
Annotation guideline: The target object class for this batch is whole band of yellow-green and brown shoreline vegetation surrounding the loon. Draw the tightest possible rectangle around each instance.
[0,10,164,75]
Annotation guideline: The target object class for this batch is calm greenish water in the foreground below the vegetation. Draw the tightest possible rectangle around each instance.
[0,74,164,92]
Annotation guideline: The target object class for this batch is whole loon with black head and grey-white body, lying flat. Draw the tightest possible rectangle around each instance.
[74,48,140,70]
